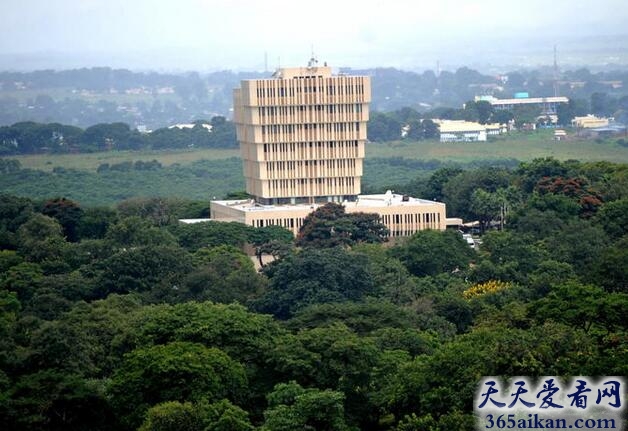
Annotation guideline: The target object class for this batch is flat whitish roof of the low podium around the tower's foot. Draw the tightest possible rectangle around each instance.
[212,192,444,212]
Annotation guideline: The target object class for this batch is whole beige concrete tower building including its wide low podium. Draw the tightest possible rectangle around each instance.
[211,59,452,237]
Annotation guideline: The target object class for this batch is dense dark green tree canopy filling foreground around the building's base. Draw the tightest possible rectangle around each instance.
[0,158,628,431]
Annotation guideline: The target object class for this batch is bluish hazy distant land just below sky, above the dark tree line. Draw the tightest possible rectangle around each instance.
[0,67,628,129]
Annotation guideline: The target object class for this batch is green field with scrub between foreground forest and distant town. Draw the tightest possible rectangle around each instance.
[0,131,628,206]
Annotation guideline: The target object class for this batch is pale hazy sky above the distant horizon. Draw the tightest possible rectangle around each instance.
[0,0,628,70]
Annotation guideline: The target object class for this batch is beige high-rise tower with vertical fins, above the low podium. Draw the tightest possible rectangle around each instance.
[234,61,371,205]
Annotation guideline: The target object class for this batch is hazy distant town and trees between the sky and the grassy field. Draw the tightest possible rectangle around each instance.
[0,67,628,154]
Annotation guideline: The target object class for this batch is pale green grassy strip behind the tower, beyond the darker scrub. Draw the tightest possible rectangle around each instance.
[12,130,628,171]
